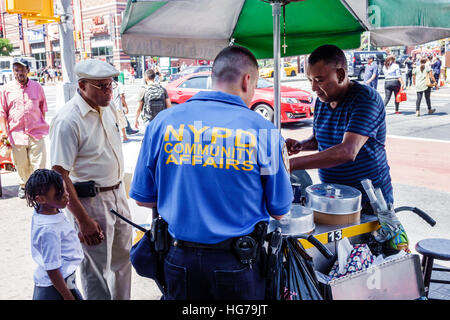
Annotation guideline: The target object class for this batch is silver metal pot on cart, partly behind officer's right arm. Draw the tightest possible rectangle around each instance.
[268,203,315,235]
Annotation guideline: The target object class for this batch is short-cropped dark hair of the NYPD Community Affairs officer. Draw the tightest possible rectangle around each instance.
[211,46,258,85]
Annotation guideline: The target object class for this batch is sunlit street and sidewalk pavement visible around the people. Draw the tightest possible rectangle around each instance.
[0,75,450,300]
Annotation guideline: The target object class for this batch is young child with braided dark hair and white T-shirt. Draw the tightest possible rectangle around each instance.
[25,169,84,300]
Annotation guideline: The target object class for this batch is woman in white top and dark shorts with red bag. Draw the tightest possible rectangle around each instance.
[383,55,404,114]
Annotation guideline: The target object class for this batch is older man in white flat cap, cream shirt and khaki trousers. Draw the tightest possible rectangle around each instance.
[50,59,132,300]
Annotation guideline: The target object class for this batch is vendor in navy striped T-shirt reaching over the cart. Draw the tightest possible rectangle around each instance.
[286,45,394,213]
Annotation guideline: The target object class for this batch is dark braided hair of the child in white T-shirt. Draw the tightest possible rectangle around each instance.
[25,169,64,210]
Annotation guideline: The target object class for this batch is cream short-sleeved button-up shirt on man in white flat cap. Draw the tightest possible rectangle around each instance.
[50,92,124,187]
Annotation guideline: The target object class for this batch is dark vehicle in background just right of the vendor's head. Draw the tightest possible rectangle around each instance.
[345,51,388,80]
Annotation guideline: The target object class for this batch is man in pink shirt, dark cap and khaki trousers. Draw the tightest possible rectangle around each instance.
[0,58,48,199]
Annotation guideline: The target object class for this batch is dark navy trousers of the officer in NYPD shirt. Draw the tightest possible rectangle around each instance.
[163,247,265,300]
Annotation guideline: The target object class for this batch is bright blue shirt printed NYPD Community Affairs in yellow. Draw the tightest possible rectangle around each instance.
[130,91,293,243]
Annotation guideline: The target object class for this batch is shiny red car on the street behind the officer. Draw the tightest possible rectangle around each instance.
[165,72,313,123]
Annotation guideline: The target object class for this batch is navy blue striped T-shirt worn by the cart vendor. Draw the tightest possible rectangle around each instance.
[313,81,394,203]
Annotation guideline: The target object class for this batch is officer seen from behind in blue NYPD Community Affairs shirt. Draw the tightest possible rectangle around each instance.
[130,46,293,300]
